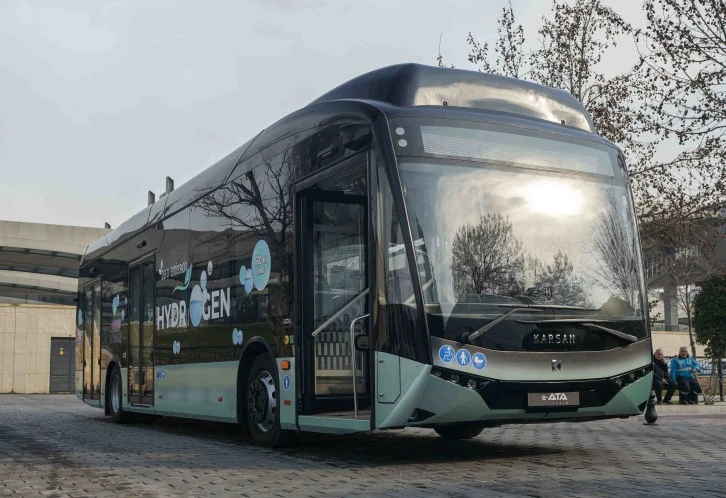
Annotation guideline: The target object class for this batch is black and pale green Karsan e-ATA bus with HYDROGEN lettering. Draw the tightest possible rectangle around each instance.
[76,64,652,447]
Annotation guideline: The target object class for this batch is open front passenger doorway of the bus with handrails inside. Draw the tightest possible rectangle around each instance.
[297,154,370,419]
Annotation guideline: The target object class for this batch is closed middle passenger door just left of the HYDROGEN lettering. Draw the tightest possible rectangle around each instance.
[128,255,156,406]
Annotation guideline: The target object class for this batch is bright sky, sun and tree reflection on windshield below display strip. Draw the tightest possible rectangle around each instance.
[399,160,642,316]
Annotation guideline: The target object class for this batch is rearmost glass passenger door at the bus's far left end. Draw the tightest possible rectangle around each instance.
[83,279,101,399]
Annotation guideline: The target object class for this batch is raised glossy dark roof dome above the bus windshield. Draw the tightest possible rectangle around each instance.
[310,64,596,133]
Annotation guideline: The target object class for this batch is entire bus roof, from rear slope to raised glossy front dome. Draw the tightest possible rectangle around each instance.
[81,64,602,265]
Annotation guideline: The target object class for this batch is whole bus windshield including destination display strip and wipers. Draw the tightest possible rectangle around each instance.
[391,120,647,350]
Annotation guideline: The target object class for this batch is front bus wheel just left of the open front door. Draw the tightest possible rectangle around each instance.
[246,354,288,448]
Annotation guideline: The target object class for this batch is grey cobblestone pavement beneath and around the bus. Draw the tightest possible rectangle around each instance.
[0,395,726,497]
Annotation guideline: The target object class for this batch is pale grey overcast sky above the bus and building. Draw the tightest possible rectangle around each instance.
[0,0,644,227]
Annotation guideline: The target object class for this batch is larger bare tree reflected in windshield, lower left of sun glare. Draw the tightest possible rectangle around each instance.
[451,213,524,297]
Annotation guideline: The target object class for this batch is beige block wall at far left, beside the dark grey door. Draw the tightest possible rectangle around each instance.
[0,304,75,394]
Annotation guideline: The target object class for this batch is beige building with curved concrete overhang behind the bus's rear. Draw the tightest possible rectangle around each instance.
[0,221,108,393]
